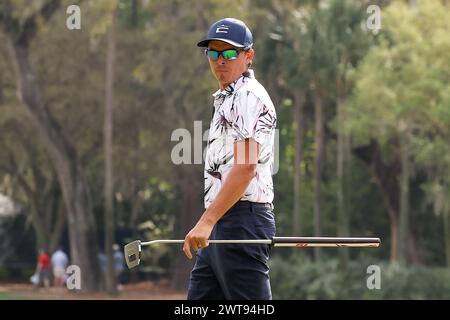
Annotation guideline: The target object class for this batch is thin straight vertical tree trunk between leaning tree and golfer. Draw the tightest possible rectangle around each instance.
[104,5,117,295]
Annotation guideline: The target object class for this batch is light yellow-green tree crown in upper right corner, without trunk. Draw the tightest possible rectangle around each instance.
[347,1,450,144]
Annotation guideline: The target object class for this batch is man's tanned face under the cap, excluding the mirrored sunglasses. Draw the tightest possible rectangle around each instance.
[208,40,253,90]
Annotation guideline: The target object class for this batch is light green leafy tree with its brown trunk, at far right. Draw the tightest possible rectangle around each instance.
[347,1,450,262]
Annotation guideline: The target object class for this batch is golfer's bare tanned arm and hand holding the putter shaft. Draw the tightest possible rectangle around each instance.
[183,139,260,259]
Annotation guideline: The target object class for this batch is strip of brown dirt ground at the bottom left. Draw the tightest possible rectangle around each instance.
[0,281,186,300]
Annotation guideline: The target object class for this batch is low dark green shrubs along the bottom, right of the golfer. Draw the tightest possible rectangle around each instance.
[270,249,450,300]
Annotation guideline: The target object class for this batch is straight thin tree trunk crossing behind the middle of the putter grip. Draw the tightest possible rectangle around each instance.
[314,86,324,261]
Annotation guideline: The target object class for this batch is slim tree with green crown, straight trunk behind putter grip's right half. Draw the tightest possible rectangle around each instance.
[326,1,371,270]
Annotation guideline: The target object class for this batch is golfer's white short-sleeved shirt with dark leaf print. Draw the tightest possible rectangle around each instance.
[204,69,277,208]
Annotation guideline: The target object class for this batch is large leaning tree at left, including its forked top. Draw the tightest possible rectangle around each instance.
[0,0,100,291]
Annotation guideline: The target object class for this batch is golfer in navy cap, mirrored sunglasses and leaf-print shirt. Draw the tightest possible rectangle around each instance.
[183,18,276,300]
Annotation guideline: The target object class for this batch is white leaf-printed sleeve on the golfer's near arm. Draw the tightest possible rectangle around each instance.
[231,91,276,145]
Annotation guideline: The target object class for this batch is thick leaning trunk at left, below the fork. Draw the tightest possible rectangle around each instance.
[8,35,100,291]
